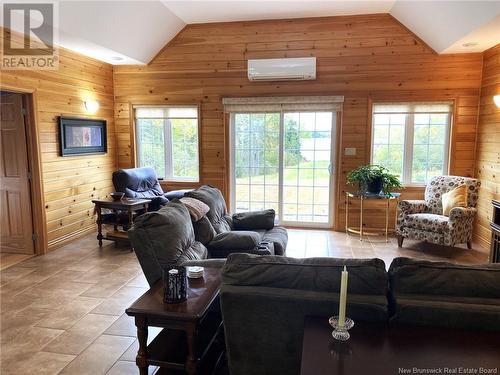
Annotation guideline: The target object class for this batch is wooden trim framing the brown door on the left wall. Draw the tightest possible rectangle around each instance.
[0,84,48,255]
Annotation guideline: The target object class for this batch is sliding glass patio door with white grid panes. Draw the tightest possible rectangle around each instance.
[231,111,336,227]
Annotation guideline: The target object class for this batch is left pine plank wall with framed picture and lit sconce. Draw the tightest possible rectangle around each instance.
[0,28,116,250]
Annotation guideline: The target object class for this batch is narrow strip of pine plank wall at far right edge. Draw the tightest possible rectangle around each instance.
[475,44,500,245]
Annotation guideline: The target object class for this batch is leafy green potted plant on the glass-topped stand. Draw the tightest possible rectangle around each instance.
[347,164,403,194]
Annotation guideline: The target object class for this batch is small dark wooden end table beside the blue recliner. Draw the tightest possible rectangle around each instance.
[92,198,151,247]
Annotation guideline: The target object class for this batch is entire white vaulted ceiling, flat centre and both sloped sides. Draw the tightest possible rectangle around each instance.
[1,0,500,65]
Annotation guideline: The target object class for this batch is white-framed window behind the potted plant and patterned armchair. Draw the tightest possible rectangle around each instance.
[371,102,453,185]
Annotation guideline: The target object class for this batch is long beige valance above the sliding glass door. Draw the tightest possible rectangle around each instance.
[222,96,344,113]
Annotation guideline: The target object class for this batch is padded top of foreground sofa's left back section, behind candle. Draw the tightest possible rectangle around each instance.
[222,254,387,296]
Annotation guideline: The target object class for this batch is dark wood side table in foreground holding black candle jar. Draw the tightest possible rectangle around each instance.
[126,268,224,375]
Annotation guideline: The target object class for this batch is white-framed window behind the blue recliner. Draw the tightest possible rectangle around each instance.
[134,106,199,181]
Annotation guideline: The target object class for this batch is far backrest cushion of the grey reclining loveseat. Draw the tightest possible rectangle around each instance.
[185,185,233,233]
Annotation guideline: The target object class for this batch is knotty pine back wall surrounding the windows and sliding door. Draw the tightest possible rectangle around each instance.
[114,14,482,229]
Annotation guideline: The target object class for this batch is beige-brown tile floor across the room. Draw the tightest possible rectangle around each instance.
[0,230,488,375]
